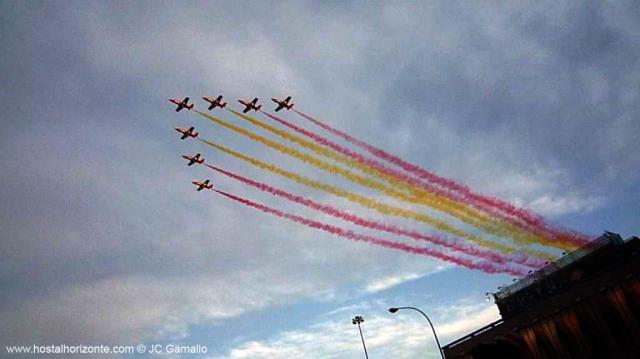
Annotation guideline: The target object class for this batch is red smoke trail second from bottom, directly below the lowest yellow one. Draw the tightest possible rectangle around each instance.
[205,164,544,268]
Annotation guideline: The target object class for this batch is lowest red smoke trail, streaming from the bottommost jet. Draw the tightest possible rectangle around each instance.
[214,189,526,276]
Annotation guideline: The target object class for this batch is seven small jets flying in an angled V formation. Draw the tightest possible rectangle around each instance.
[169,95,293,191]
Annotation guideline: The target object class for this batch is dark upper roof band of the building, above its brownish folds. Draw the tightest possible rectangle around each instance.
[443,232,640,357]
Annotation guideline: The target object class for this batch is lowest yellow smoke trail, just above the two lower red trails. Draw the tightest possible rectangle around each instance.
[200,139,555,260]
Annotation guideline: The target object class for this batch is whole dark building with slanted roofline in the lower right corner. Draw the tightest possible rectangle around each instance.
[443,232,640,359]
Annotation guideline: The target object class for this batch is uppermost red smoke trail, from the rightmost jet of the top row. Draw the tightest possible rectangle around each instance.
[292,110,590,247]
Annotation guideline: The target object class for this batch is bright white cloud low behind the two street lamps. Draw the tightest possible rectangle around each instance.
[217,303,499,359]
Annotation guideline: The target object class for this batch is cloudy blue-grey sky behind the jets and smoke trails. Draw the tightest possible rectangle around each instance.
[0,1,640,359]
